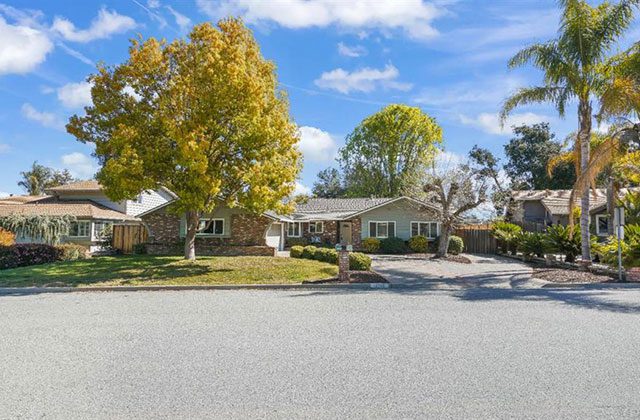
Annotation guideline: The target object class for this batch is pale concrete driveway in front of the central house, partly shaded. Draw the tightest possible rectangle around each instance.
[372,255,545,289]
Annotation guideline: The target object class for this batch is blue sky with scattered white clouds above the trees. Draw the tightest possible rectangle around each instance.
[0,0,639,196]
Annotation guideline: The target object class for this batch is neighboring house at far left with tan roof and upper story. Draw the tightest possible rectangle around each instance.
[0,181,176,252]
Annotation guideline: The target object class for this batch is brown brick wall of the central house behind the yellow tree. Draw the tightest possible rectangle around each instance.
[142,207,276,256]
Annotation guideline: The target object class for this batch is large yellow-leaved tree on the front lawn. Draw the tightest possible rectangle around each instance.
[67,19,300,259]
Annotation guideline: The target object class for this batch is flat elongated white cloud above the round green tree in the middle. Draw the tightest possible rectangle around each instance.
[314,64,412,94]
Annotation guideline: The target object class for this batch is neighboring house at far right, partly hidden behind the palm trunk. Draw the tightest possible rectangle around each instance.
[507,188,640,236]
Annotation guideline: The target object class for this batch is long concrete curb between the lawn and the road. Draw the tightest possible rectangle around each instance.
[0,283,391,296]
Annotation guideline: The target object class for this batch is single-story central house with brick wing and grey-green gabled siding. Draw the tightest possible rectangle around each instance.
[139,197,440,255]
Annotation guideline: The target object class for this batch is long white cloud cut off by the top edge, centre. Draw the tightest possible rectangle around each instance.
[197,0,445,40]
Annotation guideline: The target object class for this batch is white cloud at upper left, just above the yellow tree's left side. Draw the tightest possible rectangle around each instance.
[51,7,136,42]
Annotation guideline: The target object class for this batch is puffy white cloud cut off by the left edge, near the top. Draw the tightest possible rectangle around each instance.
[0,16,53,75]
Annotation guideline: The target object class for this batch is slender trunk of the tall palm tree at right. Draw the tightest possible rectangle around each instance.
[569,98,591,264]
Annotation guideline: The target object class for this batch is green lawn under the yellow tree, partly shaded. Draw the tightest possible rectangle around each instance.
[0,255,338,287]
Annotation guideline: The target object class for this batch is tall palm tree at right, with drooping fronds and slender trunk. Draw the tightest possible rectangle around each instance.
[501,0,640,263]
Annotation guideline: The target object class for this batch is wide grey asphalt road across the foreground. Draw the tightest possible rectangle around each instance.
[0,289,640,419]
